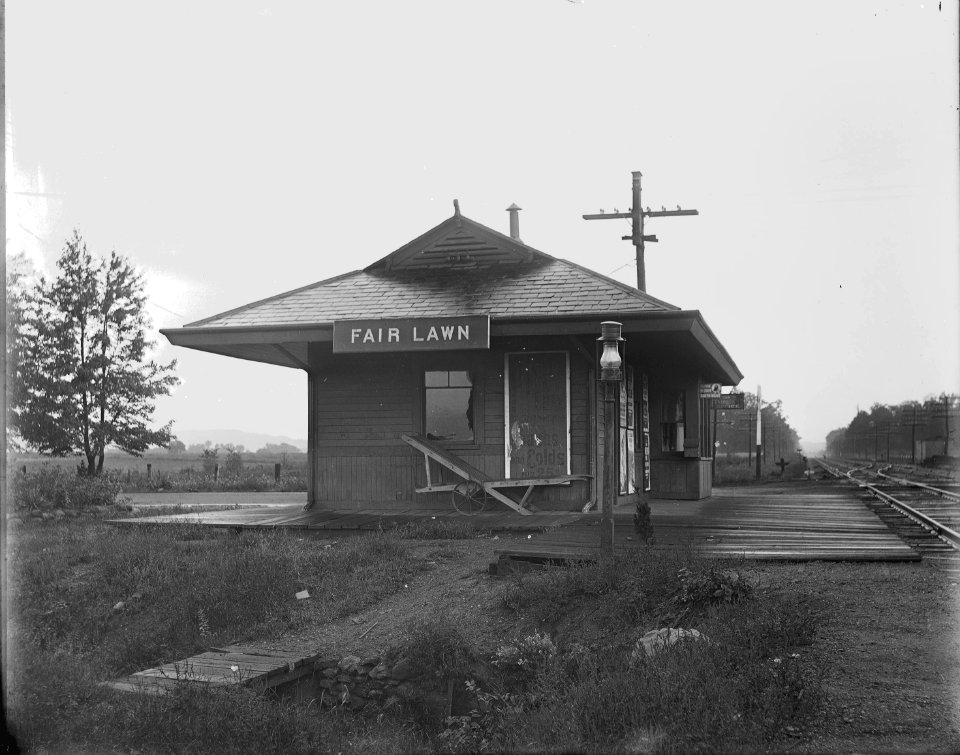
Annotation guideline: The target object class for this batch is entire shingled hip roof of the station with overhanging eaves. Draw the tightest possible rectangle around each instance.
[161,207,739,382]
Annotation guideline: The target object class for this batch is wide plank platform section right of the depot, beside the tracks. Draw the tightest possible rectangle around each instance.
[496,482,920,571]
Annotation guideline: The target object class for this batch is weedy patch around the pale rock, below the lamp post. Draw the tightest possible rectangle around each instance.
[441,549,820,752]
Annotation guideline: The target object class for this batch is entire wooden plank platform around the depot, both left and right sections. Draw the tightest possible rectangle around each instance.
[112,481,920,561]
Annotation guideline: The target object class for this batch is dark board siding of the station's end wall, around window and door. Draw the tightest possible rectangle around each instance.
[308,349,591,509]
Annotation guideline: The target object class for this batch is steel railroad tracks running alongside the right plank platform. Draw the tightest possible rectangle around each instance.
[816,459,960,577]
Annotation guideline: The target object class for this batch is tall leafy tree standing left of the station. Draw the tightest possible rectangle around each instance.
[12,231,179,475]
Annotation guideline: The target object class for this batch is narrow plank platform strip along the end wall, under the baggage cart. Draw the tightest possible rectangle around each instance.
[109,504,582,534]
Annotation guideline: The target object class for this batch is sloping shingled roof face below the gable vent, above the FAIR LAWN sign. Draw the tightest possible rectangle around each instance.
[193,258,677,327]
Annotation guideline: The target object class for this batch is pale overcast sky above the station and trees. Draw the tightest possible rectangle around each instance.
[6,0,960,446]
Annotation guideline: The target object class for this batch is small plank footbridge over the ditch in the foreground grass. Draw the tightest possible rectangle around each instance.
[101,645,320,695]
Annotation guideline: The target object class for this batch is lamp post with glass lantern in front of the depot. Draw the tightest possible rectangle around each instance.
[597,321,623,584]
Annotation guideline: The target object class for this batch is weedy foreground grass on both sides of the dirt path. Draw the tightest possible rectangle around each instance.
[7,518,819,753]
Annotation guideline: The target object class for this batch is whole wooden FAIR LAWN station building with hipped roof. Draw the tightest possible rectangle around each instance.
[161,203,743,513]
